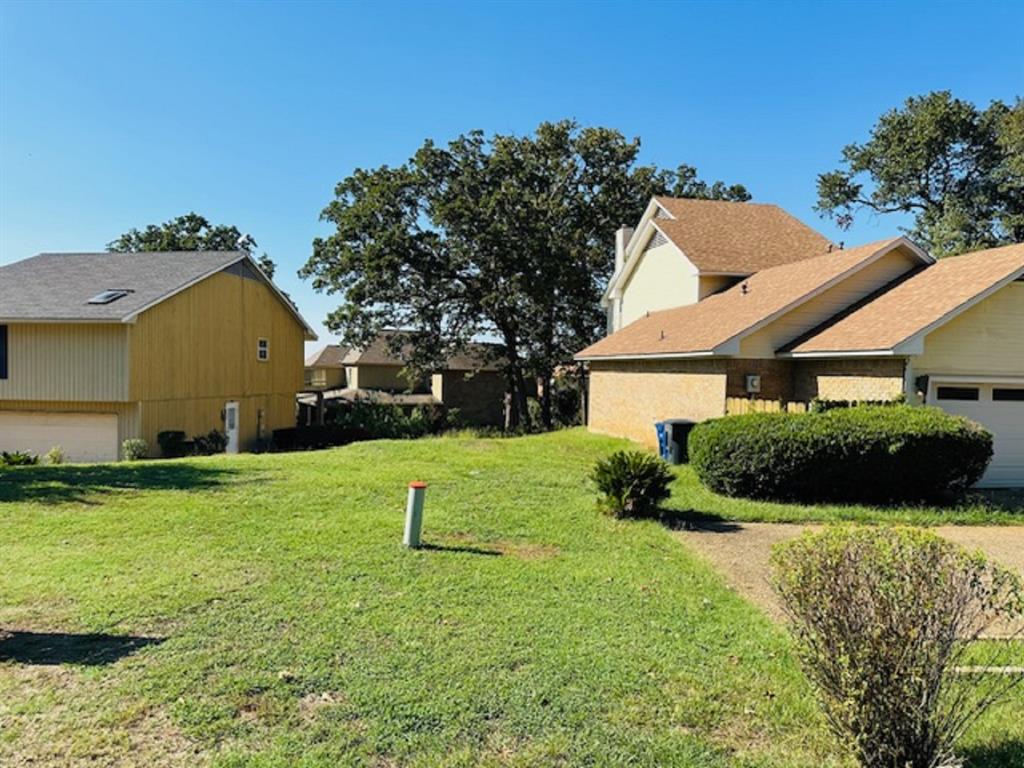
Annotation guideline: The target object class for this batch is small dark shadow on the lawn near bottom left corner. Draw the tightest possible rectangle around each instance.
[0,631,164,667]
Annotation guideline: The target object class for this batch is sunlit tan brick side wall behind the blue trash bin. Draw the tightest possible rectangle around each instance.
[588,359,727,446]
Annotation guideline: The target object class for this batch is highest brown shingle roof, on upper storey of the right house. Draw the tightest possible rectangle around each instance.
[654,198,830,274]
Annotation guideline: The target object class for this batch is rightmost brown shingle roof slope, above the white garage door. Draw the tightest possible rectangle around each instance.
[790,244,1024,354]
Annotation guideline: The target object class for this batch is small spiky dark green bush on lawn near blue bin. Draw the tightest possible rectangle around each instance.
[590,451,673,517]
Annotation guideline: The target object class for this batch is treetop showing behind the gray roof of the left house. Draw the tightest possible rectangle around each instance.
[106,212,276,280]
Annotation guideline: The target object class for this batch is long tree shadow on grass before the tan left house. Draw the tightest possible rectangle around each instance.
[0,462,240,504]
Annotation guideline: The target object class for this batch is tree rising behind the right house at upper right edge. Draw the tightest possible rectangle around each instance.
[817,91,1024,256]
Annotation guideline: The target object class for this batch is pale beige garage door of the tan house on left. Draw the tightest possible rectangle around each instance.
[0,411,118,462]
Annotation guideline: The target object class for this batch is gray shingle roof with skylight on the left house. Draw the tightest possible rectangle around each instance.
[0,251,315,338]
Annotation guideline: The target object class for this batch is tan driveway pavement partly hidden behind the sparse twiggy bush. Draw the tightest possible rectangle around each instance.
[674,521,1024,637]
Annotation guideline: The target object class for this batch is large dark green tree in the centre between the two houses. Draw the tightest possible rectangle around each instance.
[300,121,750,424]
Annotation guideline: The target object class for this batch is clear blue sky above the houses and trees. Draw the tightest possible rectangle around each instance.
[0,0,1024,352]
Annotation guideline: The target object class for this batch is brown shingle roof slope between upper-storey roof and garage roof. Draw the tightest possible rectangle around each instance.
[577,238,906,359]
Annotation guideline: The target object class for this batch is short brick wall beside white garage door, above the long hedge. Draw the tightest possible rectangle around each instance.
[794,357,904,400]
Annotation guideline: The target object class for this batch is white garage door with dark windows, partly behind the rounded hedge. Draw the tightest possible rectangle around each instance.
[929,380,1024,487]
